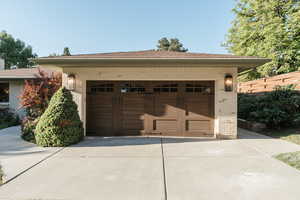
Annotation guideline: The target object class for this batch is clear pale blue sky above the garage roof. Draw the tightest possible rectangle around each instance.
[0,0,235,56]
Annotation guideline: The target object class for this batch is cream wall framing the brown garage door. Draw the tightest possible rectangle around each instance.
[63,66,237,138]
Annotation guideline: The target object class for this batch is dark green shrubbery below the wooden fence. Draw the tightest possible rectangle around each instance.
[238,86,300,128]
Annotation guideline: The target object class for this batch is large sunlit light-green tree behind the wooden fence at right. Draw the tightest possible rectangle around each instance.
[224,0,300,80]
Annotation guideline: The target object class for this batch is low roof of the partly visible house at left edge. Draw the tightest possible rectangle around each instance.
[0,67,53,80]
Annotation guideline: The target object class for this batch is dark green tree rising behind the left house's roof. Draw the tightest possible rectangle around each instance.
[0,31,37,69]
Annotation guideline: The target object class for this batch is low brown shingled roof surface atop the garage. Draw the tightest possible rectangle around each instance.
[41,50,258,59]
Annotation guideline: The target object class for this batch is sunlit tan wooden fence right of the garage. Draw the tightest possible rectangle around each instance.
[238,71,300,93]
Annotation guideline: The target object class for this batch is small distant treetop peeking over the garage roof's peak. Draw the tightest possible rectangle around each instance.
[157,37,188,52]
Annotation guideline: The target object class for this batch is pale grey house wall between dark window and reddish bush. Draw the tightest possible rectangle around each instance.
[9,80,25,118]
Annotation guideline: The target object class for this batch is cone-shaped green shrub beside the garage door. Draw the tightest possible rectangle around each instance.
[35,87,83,146]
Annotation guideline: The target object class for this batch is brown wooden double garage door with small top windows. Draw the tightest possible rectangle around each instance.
[86,81,214,136]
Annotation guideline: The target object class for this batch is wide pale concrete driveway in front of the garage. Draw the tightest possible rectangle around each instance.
[0,130,300,200]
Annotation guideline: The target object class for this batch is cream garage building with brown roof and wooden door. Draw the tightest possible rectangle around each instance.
[36,50,269,138]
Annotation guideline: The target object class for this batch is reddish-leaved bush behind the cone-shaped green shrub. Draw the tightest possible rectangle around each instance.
[19,69,62,142]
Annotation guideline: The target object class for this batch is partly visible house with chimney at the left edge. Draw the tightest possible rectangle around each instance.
[0,60,52,118]
